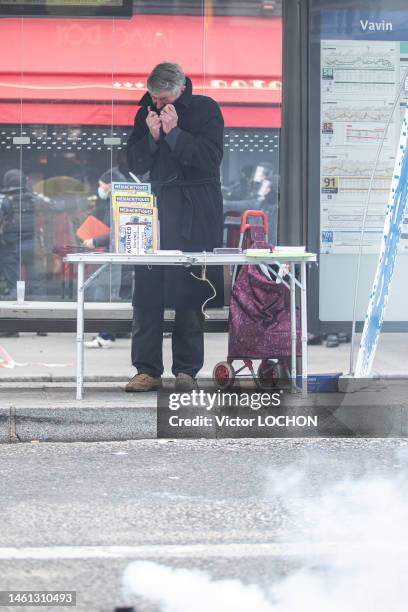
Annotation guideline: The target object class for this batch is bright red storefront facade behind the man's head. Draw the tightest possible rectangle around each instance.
[0,15,282,128]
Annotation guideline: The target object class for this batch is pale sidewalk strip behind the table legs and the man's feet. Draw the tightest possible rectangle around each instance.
[0,333,408,383]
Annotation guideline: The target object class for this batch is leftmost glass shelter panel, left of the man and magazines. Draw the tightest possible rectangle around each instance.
[0,18,113,301]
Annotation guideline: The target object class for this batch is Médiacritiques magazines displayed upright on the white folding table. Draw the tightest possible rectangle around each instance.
[111,182,158,255]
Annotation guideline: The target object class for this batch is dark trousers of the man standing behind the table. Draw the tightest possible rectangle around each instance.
[132,307,204,377]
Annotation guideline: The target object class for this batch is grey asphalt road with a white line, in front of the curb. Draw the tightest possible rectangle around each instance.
[0,439,408,612]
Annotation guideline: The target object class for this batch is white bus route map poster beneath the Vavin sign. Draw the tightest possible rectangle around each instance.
[320,12,408,253]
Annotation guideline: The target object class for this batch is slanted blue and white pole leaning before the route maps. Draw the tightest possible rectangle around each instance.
[354,106,408,378]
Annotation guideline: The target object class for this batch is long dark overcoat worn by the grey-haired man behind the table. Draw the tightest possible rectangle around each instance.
[127,78,224,308]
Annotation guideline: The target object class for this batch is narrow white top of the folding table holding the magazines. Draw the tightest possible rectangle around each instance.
[64,247,316,266]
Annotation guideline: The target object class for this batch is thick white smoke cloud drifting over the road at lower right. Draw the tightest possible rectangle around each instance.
[123,466,408,612]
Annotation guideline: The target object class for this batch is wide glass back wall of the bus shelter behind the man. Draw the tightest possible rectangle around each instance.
[0,0,282,303]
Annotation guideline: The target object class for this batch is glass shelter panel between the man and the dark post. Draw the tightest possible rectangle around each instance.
[203,1,282,246]
